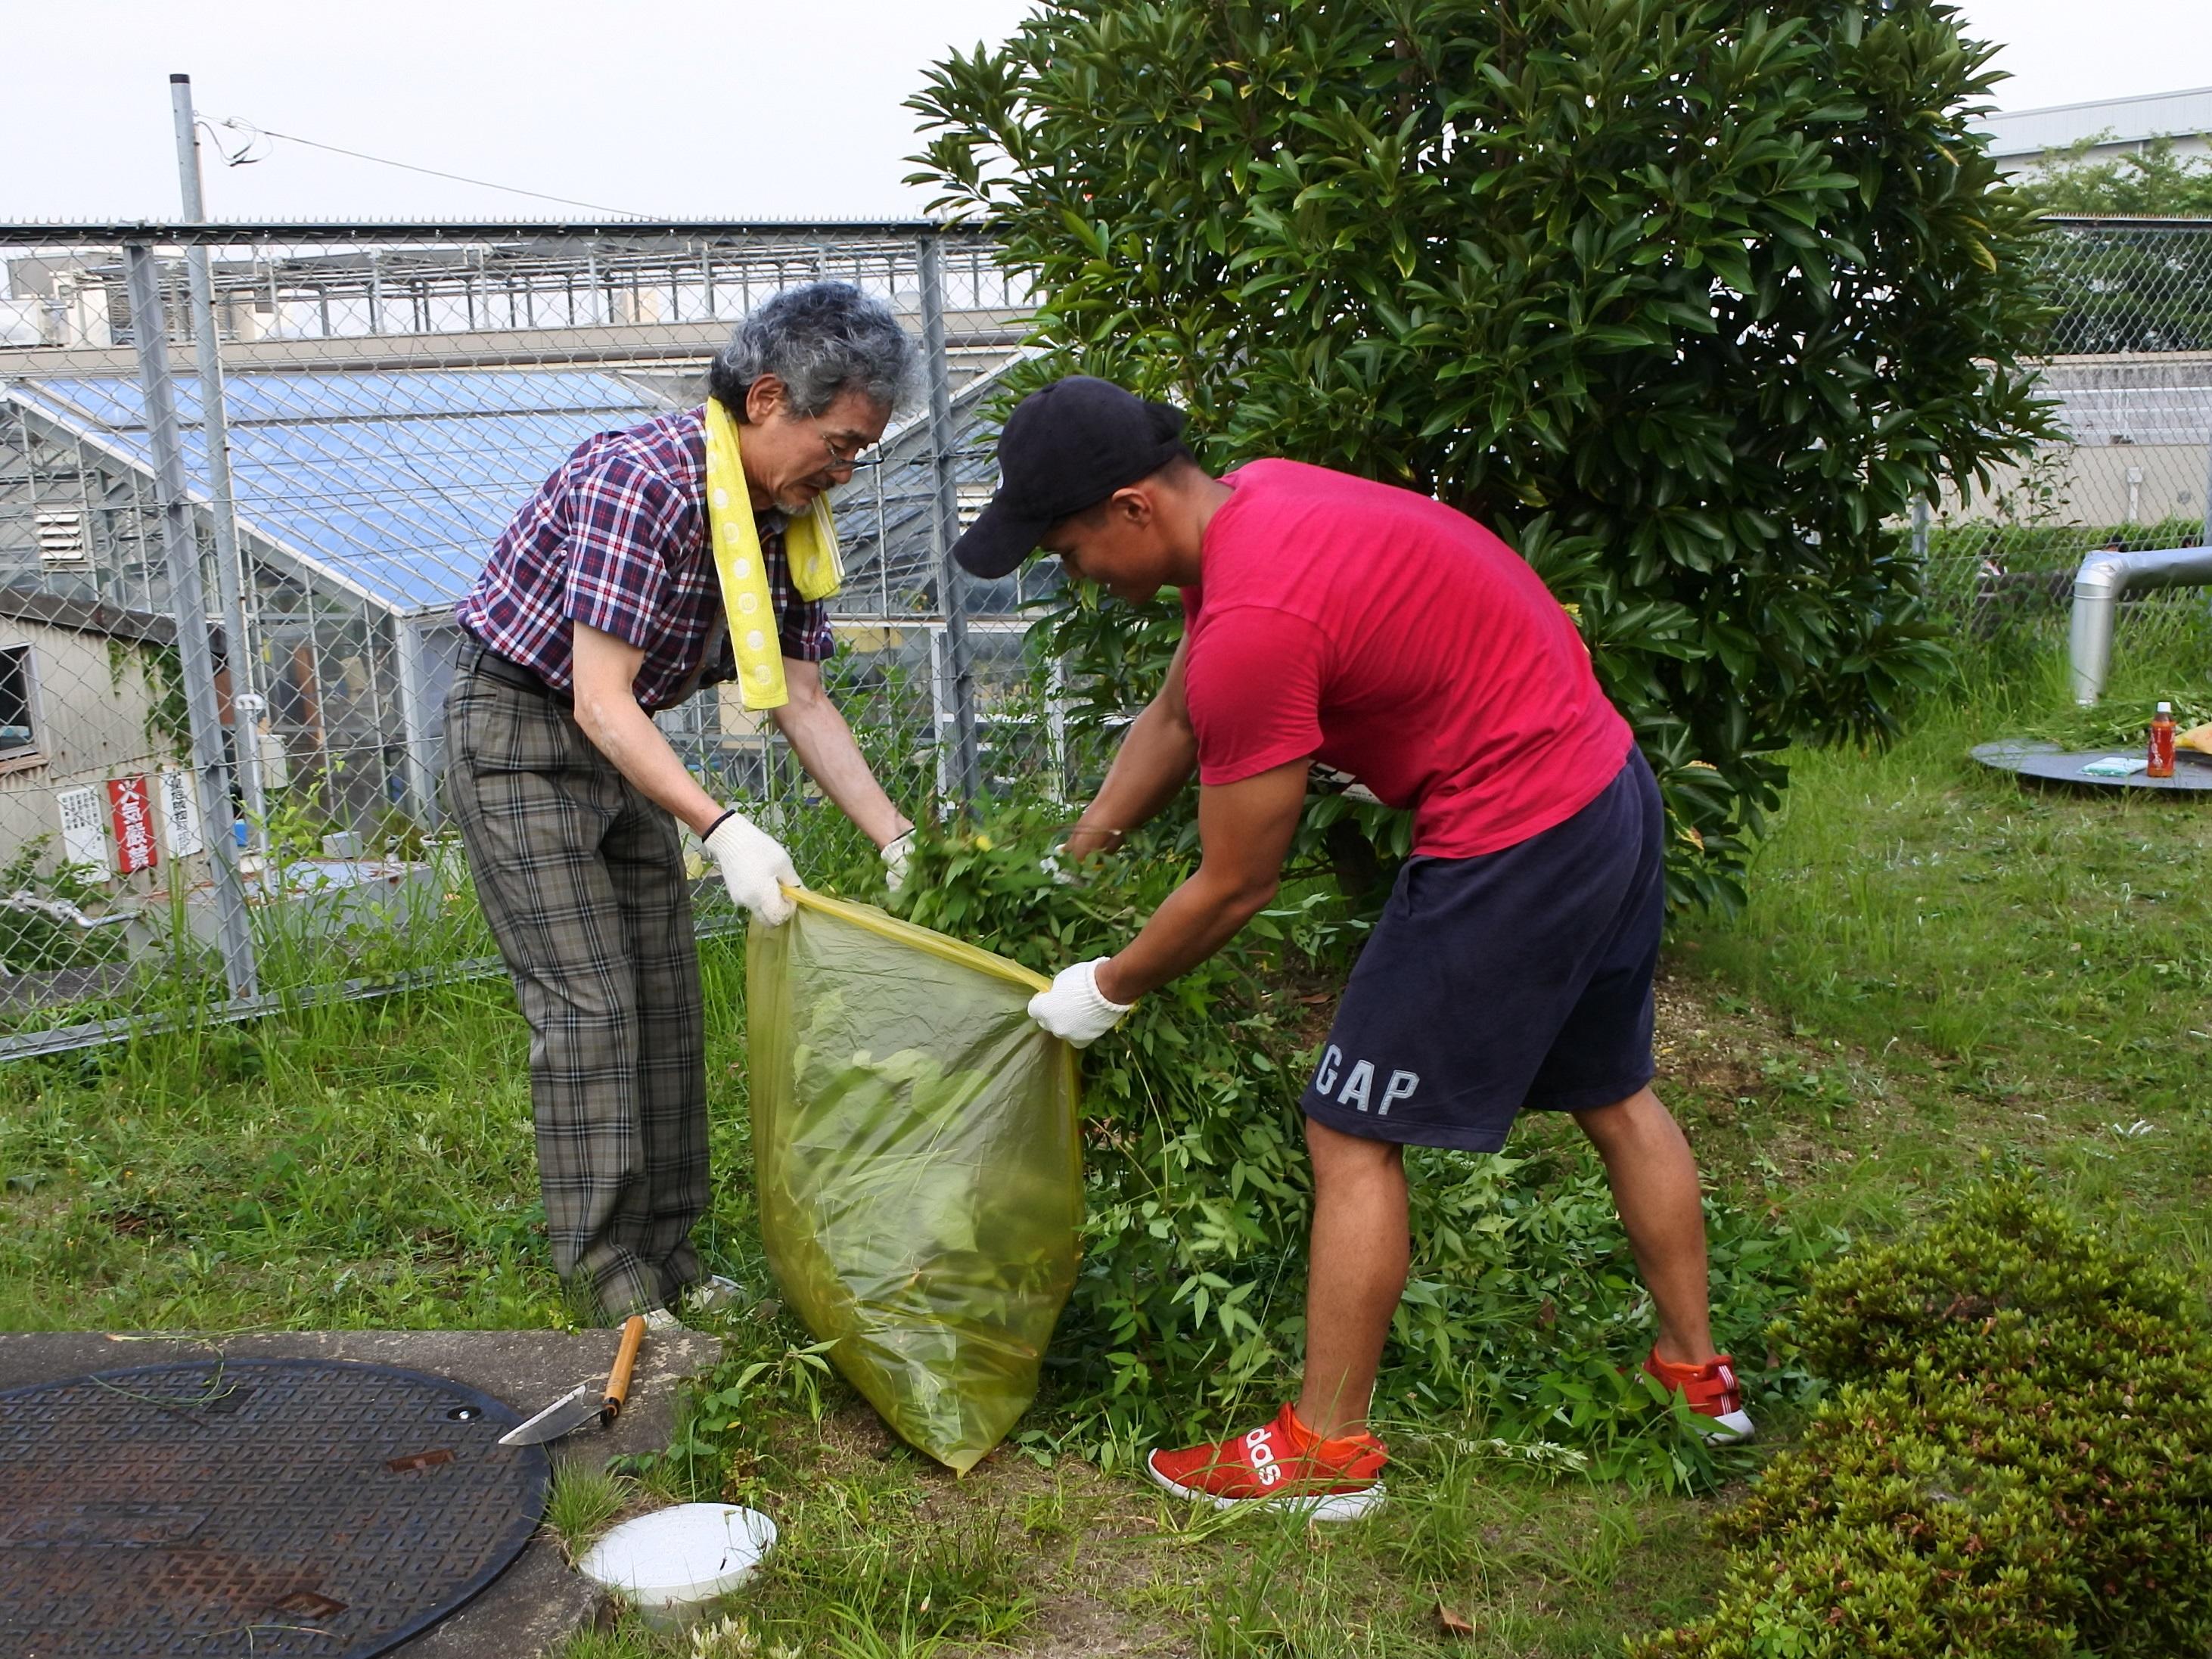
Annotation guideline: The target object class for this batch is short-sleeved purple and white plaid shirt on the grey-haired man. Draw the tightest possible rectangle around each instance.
[453,409,836,710]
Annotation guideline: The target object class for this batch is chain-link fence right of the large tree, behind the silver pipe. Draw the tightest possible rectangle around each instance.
[1913,219,2212,637]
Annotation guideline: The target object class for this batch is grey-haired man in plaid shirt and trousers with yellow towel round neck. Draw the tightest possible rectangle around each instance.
[447,283,916,1327]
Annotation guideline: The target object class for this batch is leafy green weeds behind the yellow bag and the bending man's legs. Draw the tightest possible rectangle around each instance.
[822,805,1838,1489]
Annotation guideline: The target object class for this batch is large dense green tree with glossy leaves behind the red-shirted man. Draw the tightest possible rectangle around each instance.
[914,0,2040,911]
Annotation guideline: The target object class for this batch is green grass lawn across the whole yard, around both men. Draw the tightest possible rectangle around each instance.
[0,608,2212,1659]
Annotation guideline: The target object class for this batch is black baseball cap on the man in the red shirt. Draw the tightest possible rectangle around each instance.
[953,374,1188,577]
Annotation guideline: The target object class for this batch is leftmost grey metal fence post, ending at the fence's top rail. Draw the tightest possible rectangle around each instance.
[124,241,256,1000]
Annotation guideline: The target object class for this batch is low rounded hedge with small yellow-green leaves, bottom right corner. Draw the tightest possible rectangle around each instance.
[1633,1181,2212,1659]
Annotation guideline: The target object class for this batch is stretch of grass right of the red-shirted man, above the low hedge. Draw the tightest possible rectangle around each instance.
[1674,610,2212,1276]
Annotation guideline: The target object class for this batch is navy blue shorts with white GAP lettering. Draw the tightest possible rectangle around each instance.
[1300,750,1666,1152]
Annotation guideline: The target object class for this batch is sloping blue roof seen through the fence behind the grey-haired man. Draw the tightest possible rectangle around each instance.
[15,369,663,613]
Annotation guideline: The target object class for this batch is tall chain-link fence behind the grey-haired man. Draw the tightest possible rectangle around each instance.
[0,223,1064,1058]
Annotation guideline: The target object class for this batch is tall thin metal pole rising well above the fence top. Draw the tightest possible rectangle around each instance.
[168,75,270,871]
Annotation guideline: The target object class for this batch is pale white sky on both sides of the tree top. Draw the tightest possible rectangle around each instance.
[0,0,2212,221]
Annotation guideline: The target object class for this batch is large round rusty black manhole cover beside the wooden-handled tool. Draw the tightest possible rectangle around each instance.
[0,1360,546,1659]
